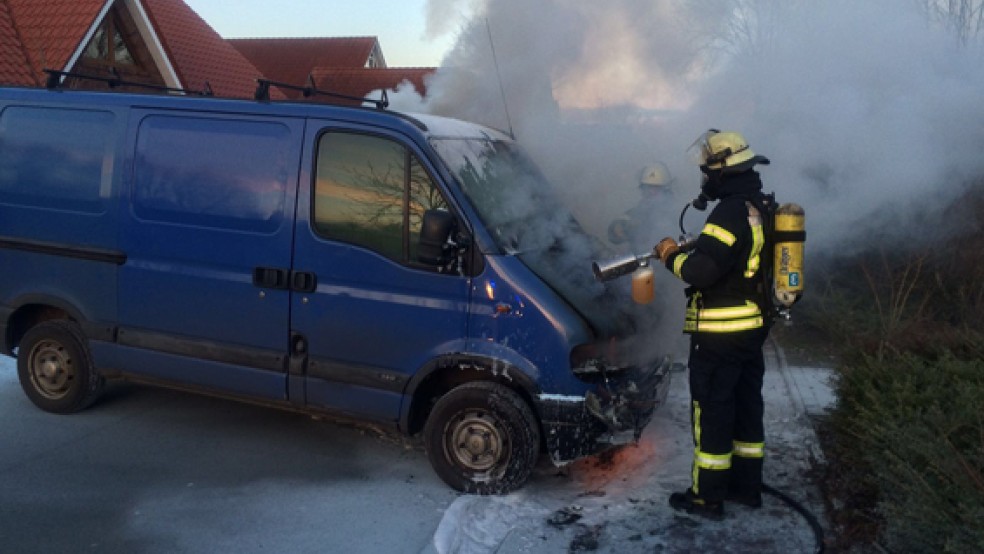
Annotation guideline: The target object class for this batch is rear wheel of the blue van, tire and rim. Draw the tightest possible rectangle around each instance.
[17,320,104,414]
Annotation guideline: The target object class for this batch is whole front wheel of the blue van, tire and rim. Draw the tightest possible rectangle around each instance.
[424,381,540,494]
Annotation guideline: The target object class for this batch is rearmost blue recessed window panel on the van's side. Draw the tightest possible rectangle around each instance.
[0,107,116,213]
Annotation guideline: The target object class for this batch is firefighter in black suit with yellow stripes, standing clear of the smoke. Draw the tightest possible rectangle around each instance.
[654,130,769,519]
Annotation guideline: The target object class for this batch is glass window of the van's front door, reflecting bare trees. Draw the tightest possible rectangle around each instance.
[313,132,448,263]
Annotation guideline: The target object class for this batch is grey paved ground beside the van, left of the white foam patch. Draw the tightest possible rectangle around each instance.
[0,359,457,554]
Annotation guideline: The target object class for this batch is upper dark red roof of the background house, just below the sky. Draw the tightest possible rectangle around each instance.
[227,37,379,90]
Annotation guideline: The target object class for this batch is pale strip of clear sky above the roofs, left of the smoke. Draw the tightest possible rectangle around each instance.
[185,0,457,67]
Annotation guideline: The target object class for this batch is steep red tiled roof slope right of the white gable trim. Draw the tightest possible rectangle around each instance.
[140,0,270,98]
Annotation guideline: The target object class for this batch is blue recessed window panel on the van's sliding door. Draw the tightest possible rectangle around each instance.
[133,116,296,233]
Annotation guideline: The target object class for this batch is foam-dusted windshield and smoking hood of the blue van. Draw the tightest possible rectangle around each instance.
[431,138,630,335]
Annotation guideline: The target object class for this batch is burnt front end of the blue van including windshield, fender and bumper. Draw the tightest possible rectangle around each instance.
[431,136,673,474]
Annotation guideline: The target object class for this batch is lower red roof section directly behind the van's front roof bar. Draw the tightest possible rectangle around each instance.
[311,67,435,104]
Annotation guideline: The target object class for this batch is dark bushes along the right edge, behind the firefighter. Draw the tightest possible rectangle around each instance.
[797,182,984,552]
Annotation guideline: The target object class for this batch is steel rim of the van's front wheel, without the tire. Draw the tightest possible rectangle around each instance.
[444,410,509,473]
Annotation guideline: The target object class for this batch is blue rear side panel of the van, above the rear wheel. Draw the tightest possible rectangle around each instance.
[0,98,126,338]
